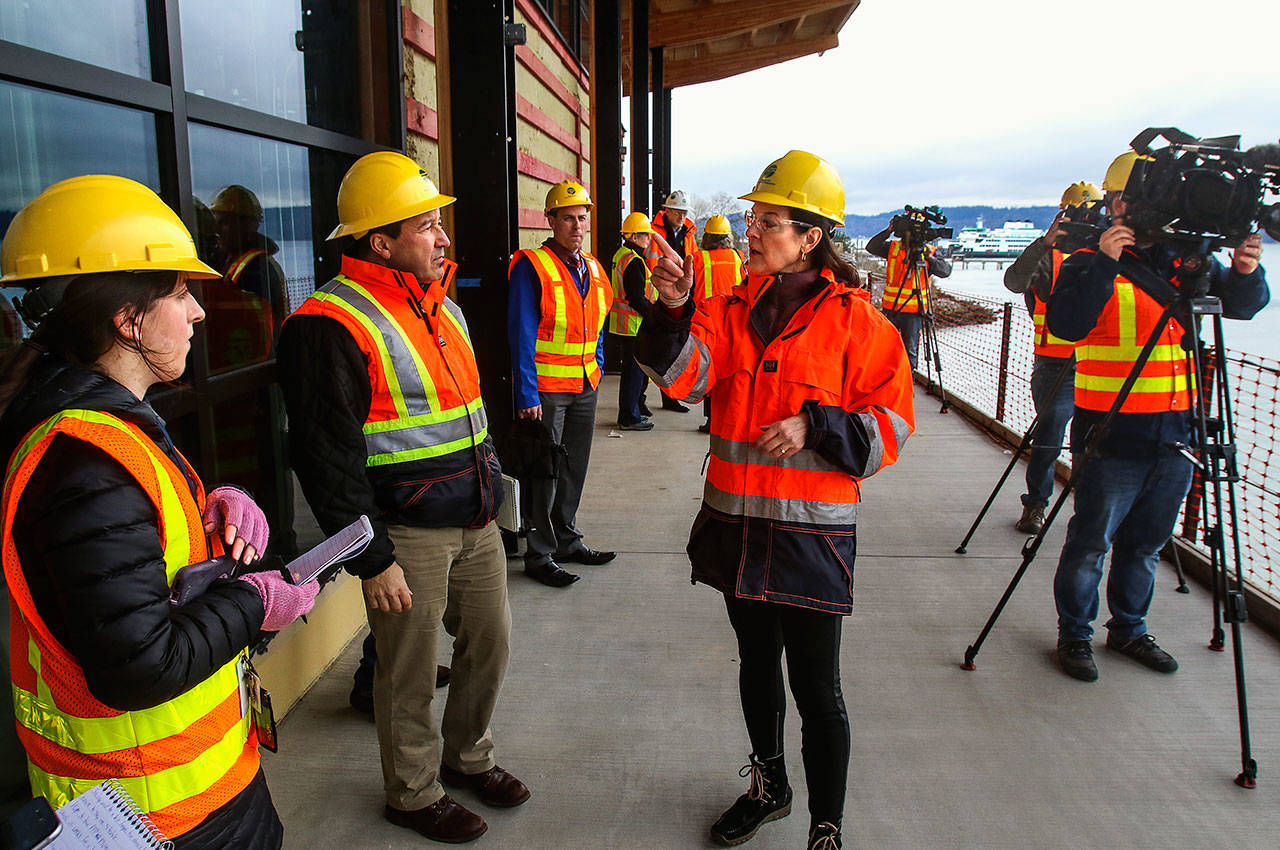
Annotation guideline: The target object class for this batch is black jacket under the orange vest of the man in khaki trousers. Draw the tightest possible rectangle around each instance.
[276,308,502,579]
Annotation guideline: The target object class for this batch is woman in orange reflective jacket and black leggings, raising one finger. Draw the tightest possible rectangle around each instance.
[636,151,914,850]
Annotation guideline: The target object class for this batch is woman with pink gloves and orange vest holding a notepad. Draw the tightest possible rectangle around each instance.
[0,175,319,850]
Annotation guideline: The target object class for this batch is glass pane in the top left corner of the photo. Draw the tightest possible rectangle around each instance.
[0,0,151,79]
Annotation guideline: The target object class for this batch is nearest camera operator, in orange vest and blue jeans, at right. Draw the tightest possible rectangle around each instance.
[1047,151,1270,681]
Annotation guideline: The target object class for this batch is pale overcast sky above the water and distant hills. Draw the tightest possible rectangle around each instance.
[655,0,1280,214]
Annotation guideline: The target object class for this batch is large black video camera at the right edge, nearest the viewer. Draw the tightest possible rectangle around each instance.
[1123,127,1280,251]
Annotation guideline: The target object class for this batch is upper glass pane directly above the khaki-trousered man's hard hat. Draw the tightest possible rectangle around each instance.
[180,0,362,136]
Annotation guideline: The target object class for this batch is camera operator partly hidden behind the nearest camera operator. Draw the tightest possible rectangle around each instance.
[1005,180,1102,534]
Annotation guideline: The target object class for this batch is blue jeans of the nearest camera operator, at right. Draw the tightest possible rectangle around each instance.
[1053,448,1192,644]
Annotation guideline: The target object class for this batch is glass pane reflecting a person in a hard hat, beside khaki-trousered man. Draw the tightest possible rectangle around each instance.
[191,124,315,373]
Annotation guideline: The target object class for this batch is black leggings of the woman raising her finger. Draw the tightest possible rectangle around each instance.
[724,597,849,824]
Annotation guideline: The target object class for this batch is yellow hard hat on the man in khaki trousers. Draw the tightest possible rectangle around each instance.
[325,151,457,239]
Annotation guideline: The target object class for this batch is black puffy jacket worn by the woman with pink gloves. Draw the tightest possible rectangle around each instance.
[0,355,279,850]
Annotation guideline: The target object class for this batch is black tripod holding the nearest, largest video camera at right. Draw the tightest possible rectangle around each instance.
[960,268,1257,789]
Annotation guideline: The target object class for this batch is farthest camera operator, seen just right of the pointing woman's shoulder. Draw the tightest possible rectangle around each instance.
[867,215,951,371]
